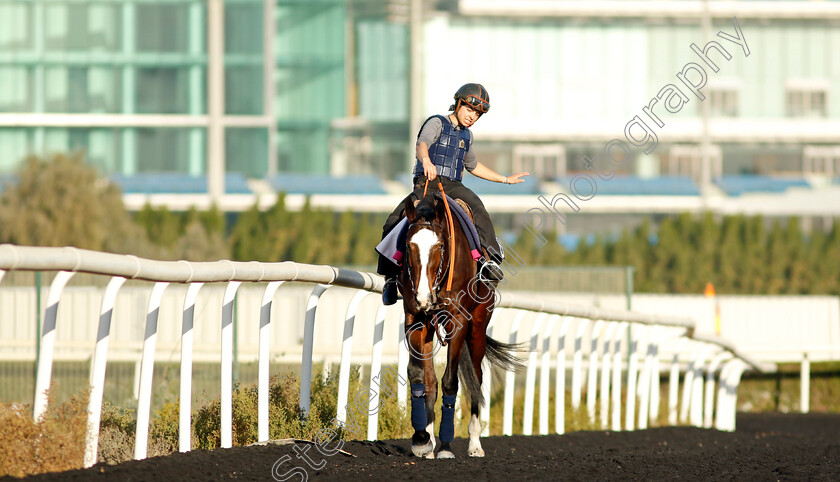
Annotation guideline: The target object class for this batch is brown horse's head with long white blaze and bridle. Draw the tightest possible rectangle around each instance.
[402,196,448,311]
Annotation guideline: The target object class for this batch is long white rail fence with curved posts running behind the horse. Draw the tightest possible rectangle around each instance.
[0,245,775,467]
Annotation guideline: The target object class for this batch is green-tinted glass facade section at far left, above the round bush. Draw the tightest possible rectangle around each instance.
[0,0,272,188]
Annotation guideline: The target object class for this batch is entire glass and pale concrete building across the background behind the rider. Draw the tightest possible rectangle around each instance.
[0,0,840,200]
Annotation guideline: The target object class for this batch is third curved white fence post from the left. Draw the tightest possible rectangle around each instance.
[134,282,169,460]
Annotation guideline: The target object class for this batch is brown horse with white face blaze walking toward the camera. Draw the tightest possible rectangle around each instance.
[397,186,523,459]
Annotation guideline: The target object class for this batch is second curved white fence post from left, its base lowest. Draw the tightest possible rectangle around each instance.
[84,276,125,467]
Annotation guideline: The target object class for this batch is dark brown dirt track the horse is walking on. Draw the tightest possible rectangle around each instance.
[13,414,840,482]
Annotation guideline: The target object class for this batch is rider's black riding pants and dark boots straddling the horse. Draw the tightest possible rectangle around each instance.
[376,176,502,276]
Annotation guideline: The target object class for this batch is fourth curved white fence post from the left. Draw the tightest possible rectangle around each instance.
[178,283,204,452]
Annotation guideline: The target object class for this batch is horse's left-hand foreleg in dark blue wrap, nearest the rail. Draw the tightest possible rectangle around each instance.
[406,315,437,457]
